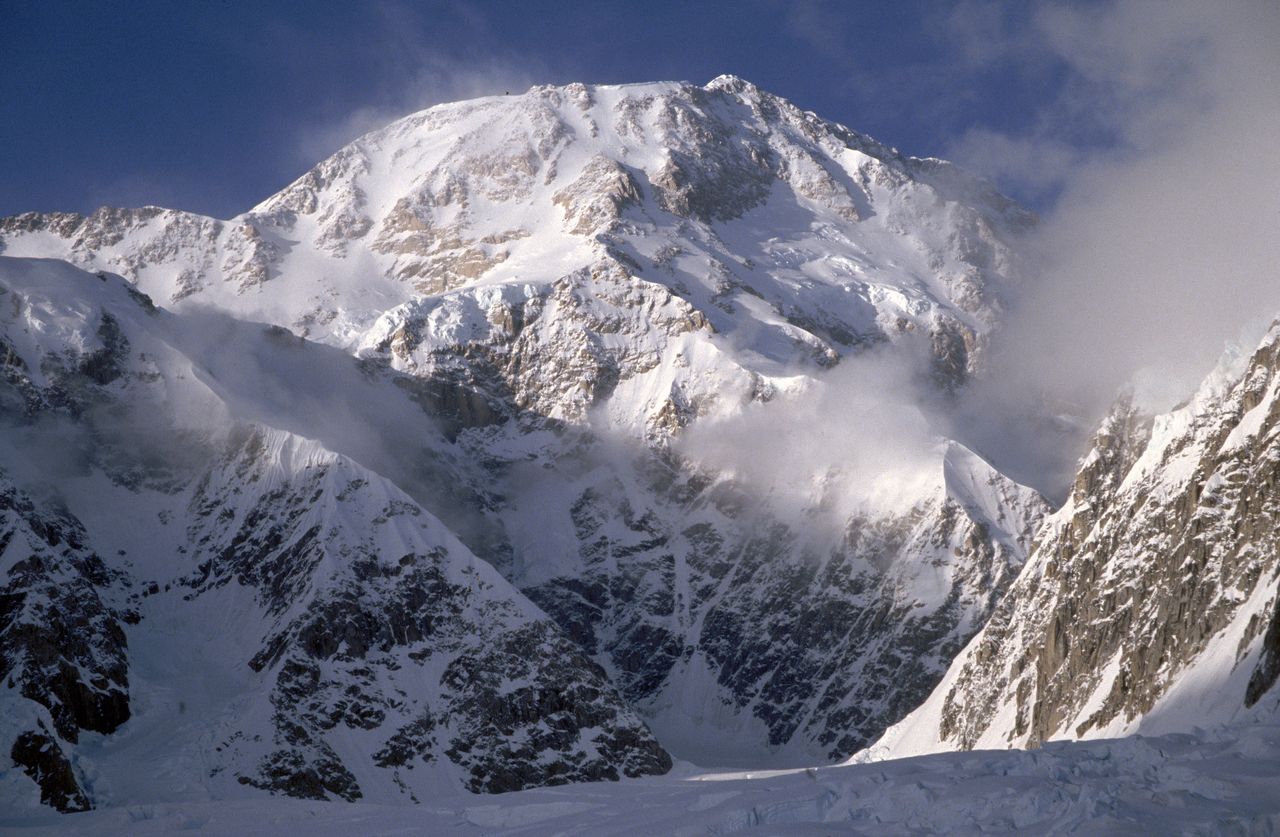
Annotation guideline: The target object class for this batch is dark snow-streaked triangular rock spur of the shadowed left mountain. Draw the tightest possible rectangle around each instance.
[188,435,671,800]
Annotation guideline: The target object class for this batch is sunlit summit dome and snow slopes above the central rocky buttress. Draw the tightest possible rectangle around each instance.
[0,76,1030,386]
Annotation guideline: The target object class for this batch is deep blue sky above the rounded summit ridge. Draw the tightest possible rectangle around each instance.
[0,0,1090,218]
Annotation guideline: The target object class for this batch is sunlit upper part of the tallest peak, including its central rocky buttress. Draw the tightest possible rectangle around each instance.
[0,77,1030,445]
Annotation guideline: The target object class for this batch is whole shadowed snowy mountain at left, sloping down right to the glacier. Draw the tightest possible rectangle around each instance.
[0,259,671,810]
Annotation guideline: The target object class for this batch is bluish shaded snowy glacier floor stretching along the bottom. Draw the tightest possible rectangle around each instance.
[0,723,1280,837]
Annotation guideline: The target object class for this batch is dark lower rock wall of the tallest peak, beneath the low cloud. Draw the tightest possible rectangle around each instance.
[507,445,1044,763]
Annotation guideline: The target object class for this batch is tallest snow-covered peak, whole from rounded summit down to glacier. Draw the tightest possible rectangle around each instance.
[0,77,1047,790]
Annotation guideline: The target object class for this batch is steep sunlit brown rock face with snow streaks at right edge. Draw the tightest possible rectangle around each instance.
[868,324,1280,756]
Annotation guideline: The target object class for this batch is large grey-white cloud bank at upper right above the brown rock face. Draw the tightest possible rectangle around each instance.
[961,0,1280,442]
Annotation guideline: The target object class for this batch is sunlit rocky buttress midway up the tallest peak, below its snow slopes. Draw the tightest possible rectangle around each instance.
[364,266,716,427]
